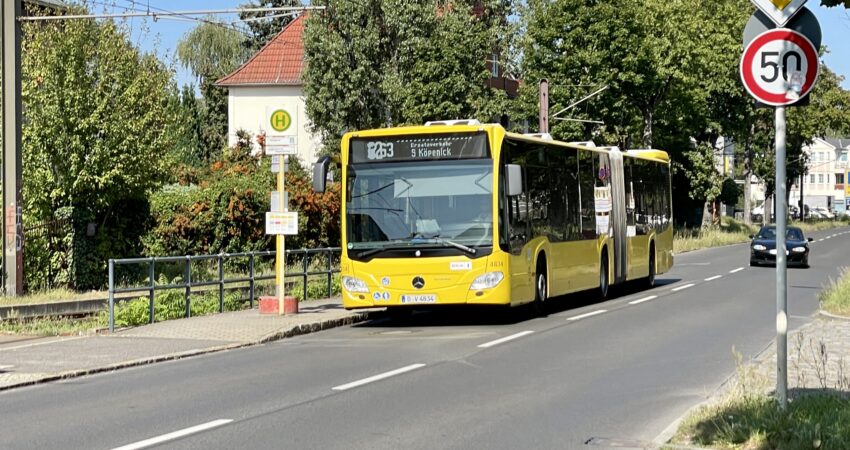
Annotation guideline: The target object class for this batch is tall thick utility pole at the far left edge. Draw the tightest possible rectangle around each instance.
[0,0,24,296]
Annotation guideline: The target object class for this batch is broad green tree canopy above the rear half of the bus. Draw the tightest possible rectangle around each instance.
[520,0,749,225]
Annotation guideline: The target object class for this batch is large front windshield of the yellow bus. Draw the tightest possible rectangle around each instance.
[345,159,493,253]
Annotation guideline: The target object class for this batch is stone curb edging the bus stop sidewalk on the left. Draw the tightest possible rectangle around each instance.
[0,311,374,392]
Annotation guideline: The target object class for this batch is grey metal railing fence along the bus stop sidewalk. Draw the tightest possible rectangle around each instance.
[109,247,341,332]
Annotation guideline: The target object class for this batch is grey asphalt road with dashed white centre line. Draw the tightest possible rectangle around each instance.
[0,229,850,449]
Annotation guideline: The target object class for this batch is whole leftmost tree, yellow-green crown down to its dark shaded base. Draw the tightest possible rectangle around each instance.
[21,8,184,289]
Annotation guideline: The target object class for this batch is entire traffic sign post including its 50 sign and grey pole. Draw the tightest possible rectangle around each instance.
[740,4,820,409]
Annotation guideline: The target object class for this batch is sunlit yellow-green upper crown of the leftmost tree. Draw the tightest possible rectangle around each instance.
[22,14,181,221]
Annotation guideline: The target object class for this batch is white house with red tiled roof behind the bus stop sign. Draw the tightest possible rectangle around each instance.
[216,14,321,166]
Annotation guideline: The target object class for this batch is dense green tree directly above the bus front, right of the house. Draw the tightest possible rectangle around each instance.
[303,0,508,152]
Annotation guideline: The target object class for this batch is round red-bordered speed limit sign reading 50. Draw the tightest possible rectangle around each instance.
[741,28,820,106]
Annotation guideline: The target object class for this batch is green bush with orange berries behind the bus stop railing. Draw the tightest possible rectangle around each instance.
[142,150,340,256]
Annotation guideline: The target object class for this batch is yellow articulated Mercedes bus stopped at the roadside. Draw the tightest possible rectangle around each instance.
[313,120,673,310]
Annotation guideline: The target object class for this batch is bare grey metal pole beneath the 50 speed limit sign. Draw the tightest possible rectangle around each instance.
[774,106,788,410]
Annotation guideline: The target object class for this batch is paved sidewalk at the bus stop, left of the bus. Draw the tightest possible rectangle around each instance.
[0,298,381,390]
